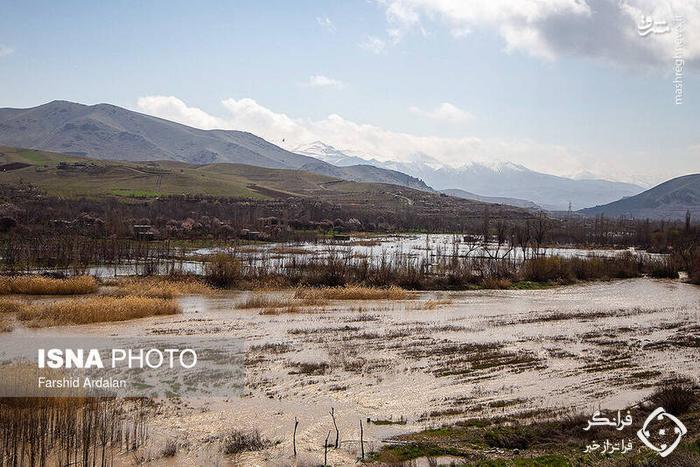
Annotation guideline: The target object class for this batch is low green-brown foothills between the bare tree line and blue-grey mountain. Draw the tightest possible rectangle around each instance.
[0,145,532,228]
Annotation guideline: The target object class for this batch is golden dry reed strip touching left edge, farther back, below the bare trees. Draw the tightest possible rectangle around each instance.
[0,276,97,295]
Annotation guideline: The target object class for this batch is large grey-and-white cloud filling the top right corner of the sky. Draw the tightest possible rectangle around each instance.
[375,0,700,65]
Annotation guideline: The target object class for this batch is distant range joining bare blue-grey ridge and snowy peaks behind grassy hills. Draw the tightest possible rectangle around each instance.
[0,101,643,210]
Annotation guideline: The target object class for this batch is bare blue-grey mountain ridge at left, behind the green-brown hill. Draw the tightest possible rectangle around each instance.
[0,101,430,191]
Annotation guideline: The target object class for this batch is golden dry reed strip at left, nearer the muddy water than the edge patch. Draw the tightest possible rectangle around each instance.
[17,297,181,327]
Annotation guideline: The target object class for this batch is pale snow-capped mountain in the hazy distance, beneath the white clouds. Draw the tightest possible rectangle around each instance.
[294,141,643,210]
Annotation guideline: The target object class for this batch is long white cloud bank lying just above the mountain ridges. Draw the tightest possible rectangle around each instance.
[137,96,605,179]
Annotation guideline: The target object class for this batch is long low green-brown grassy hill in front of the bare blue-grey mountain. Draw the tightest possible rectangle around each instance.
[0,146,530,219]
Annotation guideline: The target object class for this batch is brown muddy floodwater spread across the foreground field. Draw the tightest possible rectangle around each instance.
[15,278,700,465]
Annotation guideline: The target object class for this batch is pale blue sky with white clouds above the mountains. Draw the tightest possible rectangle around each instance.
[0,0,700,186]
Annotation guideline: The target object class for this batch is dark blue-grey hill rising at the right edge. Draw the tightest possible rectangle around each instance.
[582,174,700,220]
